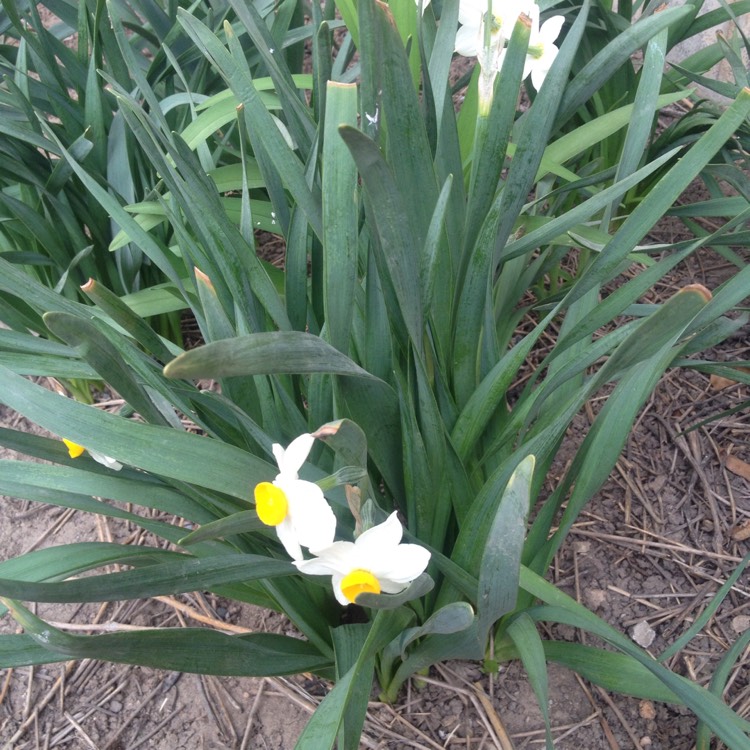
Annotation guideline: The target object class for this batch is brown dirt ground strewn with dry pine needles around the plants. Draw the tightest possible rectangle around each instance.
[0,198,750,750]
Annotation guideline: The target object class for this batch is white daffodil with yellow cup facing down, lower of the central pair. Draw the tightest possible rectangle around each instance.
[294,513,430,605]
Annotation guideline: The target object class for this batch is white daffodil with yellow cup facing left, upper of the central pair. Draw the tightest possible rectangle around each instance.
[255,434,336,560]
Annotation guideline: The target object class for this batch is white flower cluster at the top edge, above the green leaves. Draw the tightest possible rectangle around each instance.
[424,0,565,91]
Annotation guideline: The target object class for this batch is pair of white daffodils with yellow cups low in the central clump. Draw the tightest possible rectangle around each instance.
[255,434,430,605]
